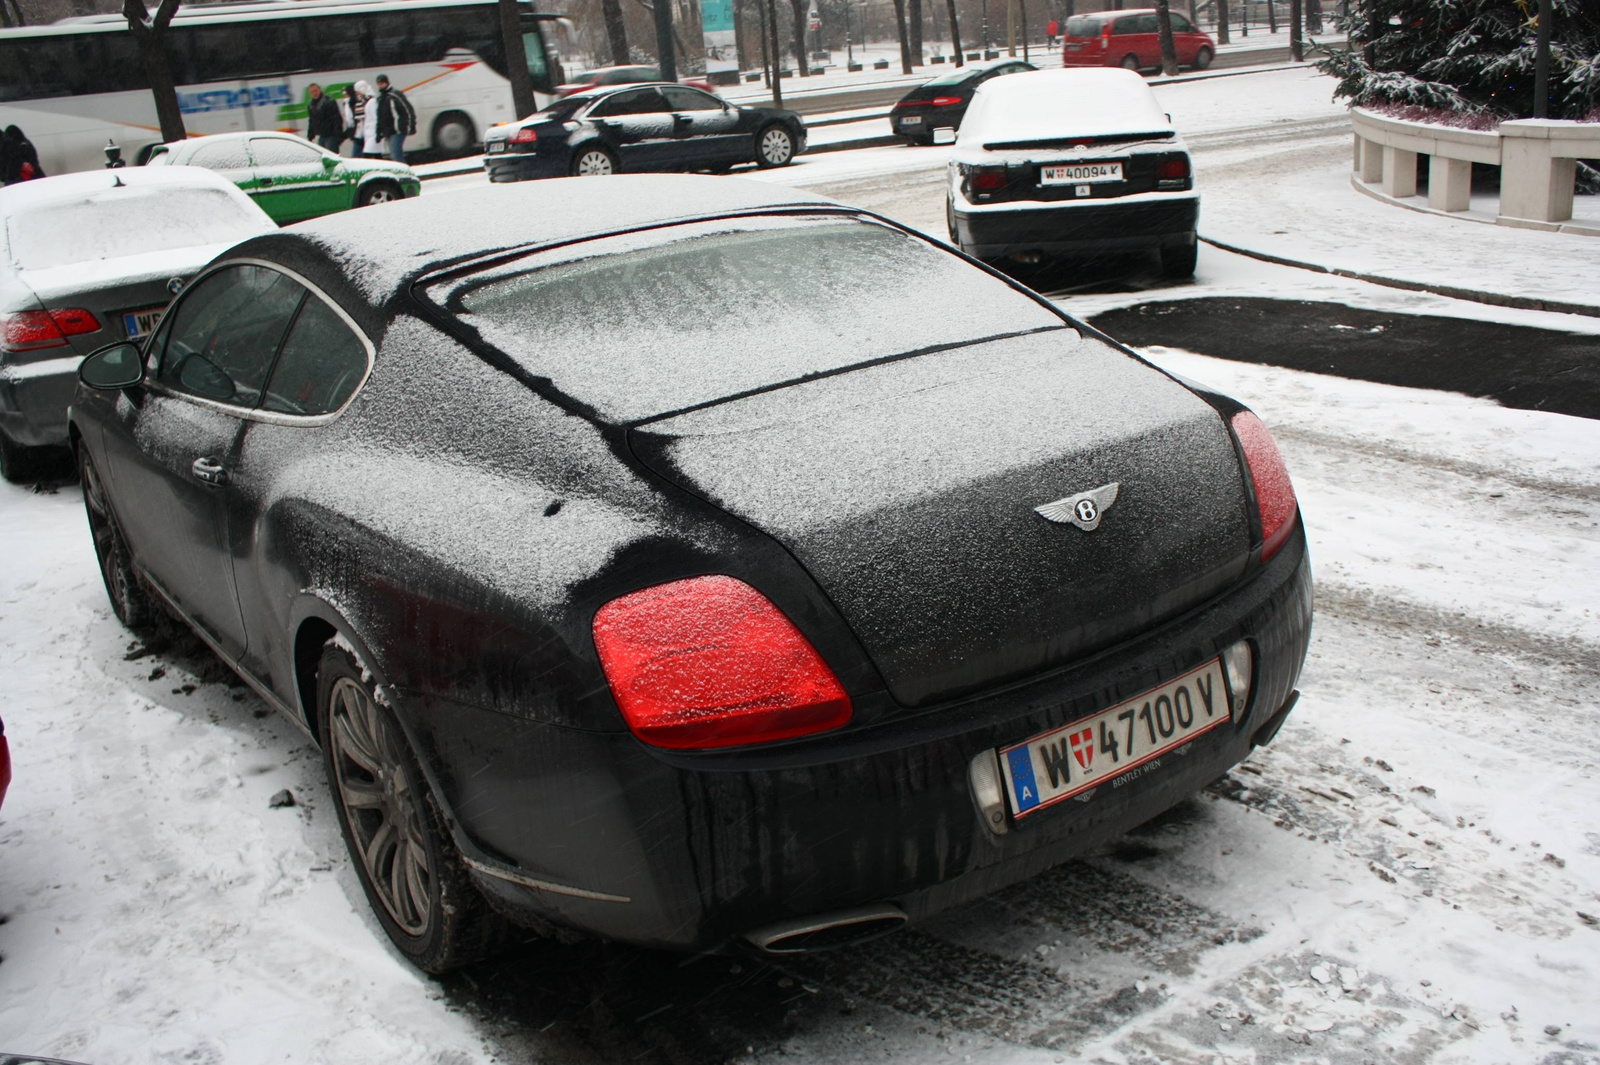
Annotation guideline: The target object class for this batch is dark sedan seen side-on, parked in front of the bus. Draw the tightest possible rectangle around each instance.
[483,83,805,181]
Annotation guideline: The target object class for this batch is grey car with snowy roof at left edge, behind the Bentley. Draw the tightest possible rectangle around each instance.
[0,168,272,480]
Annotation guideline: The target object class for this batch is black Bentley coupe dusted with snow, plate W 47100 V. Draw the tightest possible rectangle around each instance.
[72,176,1312,971]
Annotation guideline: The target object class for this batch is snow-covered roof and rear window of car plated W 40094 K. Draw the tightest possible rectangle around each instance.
[955,67,1173,150]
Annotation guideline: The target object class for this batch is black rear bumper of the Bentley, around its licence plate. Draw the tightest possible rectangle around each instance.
[403,531,1312,950]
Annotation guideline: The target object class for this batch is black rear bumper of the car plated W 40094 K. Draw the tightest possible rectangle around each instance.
[954,192,1200,259]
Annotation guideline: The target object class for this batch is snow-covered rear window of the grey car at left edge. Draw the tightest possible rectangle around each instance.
[6,187,264,270]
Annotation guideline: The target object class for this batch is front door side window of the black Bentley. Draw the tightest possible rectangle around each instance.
[157,265,306,408]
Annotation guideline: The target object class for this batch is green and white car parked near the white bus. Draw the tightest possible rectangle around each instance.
[146,133,422,225]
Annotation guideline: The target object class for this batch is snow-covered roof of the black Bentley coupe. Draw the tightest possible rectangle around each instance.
[237,174,838,305]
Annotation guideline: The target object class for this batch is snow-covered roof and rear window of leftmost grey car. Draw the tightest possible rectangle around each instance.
[0,166,277,279]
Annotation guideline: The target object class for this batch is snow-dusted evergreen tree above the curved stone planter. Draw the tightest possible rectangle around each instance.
[1318,0,1600,125]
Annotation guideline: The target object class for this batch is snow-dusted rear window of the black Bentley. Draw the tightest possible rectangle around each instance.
[429,216,1067,422]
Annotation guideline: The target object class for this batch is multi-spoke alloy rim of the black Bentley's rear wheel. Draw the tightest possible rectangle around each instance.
[328,676,434,935]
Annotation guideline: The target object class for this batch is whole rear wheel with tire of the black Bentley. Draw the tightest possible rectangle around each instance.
[317,643,510,974]
